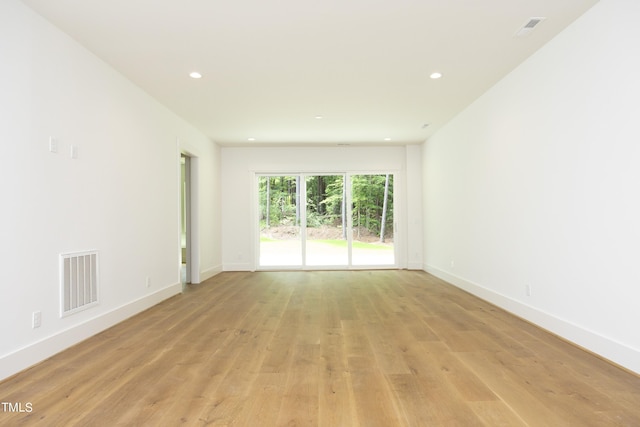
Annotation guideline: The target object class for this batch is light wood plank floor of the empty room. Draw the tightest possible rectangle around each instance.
[0,271,640,427]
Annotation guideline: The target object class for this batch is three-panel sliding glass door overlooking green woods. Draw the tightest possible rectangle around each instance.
[257,173,396,269]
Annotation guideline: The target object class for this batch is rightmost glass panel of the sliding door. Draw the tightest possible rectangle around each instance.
[351,174,395,266]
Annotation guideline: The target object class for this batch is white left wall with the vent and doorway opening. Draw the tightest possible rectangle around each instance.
[0,0,221,378]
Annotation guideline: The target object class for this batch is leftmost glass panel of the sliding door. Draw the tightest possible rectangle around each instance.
[258,175,303,267]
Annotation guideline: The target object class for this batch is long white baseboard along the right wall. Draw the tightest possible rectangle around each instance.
[424,265,640,374]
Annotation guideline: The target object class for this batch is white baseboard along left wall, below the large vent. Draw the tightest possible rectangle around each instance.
[0,283,182,380]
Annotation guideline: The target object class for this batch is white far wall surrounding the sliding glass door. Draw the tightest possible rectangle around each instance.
[222,147,422,271]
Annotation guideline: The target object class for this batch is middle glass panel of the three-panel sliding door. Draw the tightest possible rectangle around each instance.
[305,175,349,267]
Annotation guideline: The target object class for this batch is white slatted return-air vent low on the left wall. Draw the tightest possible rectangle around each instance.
[60,251,98,317]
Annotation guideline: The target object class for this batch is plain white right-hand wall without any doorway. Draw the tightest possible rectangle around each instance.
[423,0,640,372]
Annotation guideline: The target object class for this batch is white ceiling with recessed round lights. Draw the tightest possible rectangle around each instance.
[23,0,597,145]
